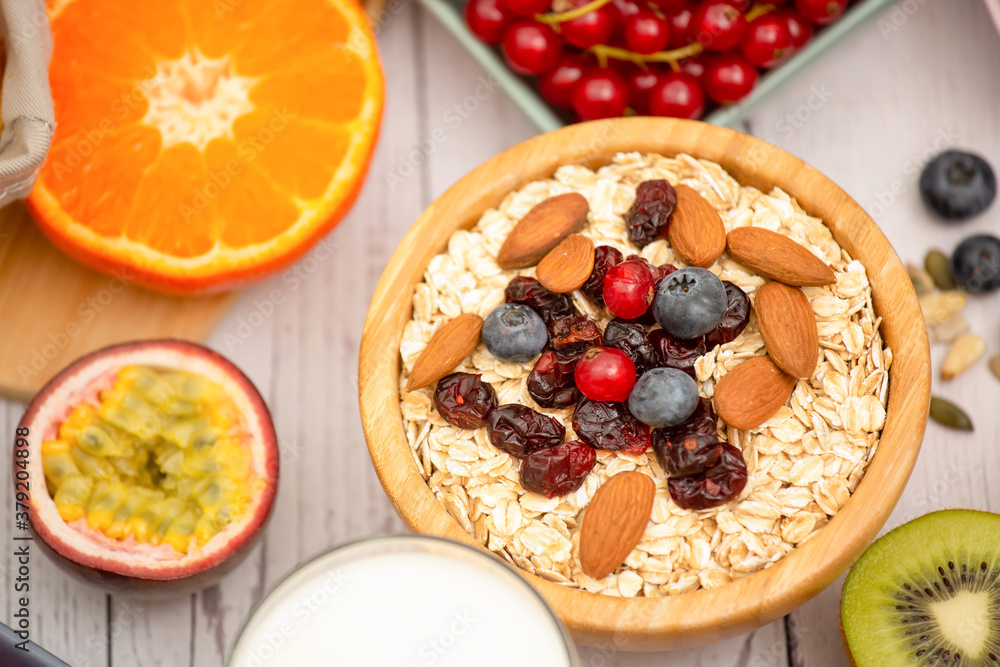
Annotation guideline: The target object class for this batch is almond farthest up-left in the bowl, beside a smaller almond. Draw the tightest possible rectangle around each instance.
[497,192,590,269]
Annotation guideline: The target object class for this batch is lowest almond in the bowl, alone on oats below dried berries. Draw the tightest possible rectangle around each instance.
[580,471,656,579]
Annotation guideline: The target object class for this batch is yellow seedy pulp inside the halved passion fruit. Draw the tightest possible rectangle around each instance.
[42,366,254,553]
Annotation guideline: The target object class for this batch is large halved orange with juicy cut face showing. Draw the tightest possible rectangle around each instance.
[28,0,383,294]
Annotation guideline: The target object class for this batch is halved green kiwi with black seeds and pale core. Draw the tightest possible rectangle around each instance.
[840,510,1000,667]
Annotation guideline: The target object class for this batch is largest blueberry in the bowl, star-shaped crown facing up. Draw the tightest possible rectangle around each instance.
[653,266,729,339]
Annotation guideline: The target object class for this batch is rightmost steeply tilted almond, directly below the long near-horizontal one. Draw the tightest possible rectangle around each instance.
[753,282,819,380]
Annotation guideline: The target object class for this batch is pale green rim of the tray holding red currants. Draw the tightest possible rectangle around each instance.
[420,0,895,132]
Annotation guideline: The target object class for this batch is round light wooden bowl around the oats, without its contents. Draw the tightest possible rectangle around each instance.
[359,118,930,650]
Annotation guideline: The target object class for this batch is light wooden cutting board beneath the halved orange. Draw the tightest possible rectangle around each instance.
[0,202,236,400]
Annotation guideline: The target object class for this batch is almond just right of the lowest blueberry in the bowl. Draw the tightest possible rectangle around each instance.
[715,356,795,429]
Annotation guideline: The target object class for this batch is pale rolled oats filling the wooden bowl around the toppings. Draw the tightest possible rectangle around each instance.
[400,153,888,597]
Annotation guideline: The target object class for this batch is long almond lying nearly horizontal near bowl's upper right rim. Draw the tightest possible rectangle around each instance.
[726,227,837,287]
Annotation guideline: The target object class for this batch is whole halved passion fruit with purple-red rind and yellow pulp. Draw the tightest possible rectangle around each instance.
[14,340,279,597]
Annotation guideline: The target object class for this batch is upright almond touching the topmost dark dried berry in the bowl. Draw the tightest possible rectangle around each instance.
[667,184,726,268]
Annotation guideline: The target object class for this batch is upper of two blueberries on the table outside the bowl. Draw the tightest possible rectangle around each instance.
[920,151,997,220]
